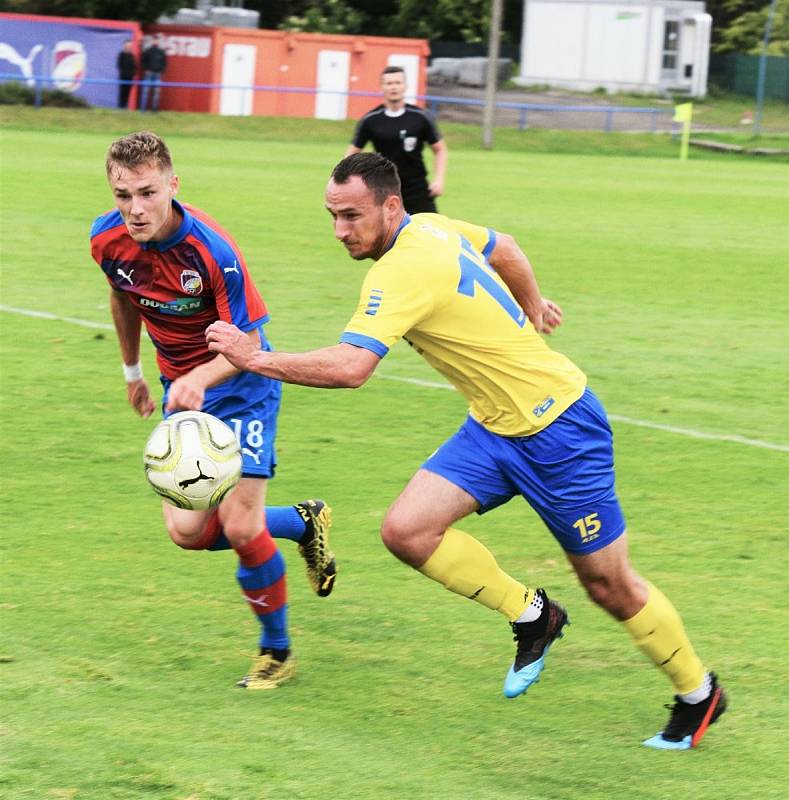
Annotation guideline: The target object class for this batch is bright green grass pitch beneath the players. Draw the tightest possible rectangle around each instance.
[0,112,789,800]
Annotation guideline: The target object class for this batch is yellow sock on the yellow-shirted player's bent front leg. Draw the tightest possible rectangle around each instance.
[419,528,534,622]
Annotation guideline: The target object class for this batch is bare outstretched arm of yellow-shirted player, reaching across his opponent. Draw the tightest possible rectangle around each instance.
[206,322,381,389]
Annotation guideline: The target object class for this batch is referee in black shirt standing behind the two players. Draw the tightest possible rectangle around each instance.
[345,67,447,214]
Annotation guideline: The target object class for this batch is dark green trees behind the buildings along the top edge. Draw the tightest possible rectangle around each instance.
[0,0,789,56]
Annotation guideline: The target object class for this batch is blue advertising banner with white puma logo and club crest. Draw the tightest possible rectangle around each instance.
[0,14,136,107]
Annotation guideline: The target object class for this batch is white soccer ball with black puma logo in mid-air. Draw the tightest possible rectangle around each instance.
[143,411,241,509]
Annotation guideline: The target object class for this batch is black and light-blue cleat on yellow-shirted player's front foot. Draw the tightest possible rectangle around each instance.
[504,589,570,697]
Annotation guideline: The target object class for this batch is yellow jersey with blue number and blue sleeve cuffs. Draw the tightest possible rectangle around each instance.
[340,214,586,436]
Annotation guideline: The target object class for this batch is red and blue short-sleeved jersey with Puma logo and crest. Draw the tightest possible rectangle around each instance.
[90,200,268,380]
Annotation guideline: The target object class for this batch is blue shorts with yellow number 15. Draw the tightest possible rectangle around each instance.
[422,389,625,554]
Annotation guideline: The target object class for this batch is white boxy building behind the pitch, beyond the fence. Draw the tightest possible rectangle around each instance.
[516,0,712,97]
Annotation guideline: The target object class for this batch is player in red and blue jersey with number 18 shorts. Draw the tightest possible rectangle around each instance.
[90,132,336,689]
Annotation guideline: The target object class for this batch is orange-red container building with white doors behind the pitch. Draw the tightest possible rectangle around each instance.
[145,25,430,119]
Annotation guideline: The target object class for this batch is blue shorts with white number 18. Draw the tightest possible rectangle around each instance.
[161,343,282,478]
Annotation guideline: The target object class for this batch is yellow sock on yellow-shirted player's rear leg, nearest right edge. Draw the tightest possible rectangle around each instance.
[622,583,705,694]
